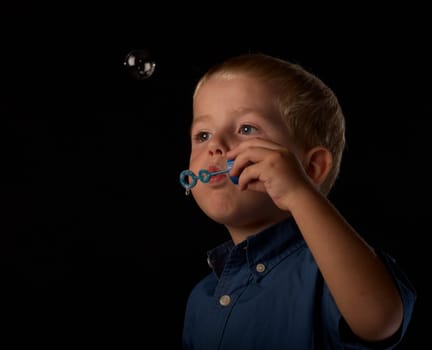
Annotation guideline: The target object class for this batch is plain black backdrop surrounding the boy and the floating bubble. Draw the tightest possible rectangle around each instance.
[0,3,431,349]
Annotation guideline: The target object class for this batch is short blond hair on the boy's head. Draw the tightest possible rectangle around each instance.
[193,53,345,195]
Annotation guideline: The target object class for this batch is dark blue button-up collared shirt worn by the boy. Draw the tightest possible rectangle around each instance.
[183,219,416,350]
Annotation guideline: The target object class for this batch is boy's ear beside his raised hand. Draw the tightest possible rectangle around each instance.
[305,147,333,186]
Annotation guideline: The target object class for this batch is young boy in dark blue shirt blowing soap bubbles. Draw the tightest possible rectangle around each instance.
[183,54,416,350]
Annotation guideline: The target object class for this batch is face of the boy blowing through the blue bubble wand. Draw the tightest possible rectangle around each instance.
[189,76,292,227]
